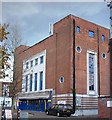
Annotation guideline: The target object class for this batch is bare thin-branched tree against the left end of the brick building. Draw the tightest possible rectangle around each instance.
[5,24,25,113]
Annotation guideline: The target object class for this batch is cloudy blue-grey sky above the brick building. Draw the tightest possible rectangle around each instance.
[0,2,110,45]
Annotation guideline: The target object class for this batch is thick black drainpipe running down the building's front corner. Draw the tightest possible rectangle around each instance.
[72,19,76,113]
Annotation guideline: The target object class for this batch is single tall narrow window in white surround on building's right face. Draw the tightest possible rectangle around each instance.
[87,51,98,95]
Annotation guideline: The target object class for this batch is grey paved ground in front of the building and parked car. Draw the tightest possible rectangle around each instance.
[13,110,102,120]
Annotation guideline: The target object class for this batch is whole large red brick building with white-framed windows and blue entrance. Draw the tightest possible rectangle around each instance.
[15,15,110,114]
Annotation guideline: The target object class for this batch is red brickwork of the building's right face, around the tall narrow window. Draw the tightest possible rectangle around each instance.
[73,17,110,95]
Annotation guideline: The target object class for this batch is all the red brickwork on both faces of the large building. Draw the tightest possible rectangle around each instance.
[16,15,109,95]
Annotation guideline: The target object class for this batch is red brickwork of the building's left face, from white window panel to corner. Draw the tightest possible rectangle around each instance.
[16,17,72,93]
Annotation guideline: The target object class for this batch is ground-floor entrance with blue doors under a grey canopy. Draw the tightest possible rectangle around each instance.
[17,91,52,111]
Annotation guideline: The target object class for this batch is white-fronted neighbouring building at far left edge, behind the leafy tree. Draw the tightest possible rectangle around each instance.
[0,46,12,108]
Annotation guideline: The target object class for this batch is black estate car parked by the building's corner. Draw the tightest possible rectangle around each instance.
[45,104,73,117]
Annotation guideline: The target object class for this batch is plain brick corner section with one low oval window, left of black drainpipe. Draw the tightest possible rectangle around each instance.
[54,16,73,94]
